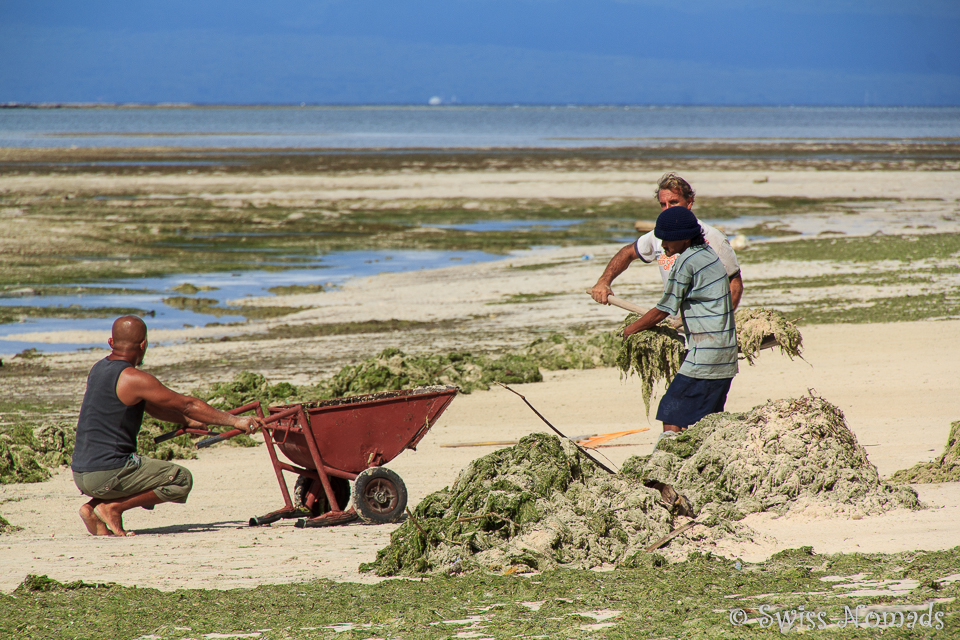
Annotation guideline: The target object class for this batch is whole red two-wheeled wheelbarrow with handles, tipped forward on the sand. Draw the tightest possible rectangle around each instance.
[154,386,459,527]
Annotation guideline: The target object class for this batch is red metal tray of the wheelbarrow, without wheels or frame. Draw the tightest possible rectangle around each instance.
[267,386,458,480]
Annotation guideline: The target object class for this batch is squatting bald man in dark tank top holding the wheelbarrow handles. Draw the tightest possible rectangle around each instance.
[71,316,263,536]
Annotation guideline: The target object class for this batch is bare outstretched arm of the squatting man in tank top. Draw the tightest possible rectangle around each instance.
[117,367,263,433]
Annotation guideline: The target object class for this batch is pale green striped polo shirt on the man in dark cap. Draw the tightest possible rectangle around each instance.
[657,244,738,379]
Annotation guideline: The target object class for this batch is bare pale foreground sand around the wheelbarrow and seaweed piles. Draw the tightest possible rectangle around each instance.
[0,321,960,591]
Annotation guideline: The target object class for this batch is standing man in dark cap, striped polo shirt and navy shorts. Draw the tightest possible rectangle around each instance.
[623,207,738,433]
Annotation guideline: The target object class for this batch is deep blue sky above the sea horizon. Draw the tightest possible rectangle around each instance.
[0,0,960,105]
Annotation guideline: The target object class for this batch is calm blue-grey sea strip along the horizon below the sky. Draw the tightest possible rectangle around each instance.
[0,105,960,149]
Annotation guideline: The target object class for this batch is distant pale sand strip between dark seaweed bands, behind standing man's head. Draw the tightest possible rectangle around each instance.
[0,170,960,203]
